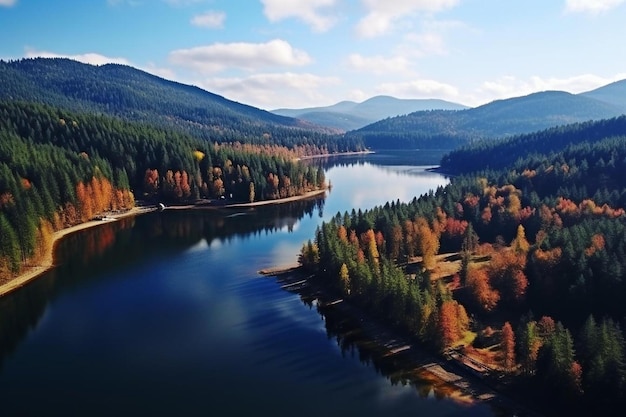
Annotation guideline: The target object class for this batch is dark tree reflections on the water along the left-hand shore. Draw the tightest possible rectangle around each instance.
[0,198,324,367]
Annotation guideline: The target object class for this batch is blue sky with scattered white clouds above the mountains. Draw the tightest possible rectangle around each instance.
[0,0,626,110]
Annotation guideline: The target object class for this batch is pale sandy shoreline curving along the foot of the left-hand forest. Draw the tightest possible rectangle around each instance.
[0,188,328,298]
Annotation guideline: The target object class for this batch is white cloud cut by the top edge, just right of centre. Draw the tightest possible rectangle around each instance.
[356,0,459,38]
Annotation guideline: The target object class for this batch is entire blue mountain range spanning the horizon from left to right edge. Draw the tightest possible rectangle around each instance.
[0,58,626,151]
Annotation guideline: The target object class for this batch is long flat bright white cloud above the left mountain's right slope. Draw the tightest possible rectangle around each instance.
[169,39,311,73]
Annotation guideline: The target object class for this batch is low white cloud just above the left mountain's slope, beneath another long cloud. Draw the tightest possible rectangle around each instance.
[198,72,340,110]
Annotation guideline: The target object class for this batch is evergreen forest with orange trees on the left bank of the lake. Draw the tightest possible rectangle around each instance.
[0,101,326,280]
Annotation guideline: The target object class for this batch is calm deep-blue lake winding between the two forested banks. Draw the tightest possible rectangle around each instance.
[0,152,503,417]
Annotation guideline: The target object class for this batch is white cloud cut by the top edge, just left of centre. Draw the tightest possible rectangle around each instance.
[261,0,336,32]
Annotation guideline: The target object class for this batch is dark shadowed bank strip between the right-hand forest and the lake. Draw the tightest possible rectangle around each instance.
[258,264,539,417]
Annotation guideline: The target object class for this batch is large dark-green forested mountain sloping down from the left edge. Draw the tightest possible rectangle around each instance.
[0,58,358,147]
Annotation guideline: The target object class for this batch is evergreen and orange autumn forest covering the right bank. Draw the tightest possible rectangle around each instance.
[299,118,626,415]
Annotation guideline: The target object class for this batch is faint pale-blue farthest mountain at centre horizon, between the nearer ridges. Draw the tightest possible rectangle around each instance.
[272,96,467,131]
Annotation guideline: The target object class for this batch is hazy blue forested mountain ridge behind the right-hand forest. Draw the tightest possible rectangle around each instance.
[347,91,624,149]
